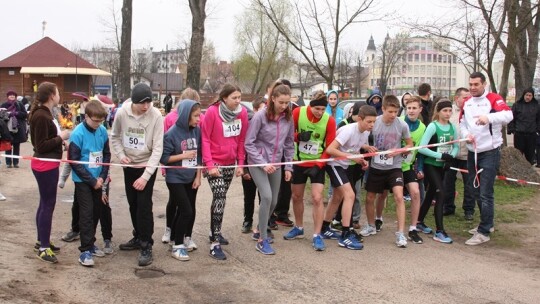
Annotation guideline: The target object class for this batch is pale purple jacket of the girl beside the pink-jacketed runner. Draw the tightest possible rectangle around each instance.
[245,108,294,171]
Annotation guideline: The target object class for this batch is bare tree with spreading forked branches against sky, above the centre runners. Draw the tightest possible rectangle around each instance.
[256,0,376,87]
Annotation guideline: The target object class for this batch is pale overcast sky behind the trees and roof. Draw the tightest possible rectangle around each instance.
[0,0,457,61]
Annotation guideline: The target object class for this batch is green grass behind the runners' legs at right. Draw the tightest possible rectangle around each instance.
[384,179,539,247]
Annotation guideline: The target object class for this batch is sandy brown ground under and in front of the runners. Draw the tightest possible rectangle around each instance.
[0,144,540,303]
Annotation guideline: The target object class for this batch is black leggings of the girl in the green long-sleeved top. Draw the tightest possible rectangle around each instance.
[418,164,444,231]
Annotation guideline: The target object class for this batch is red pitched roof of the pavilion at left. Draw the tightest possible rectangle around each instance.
[0,37,97,69]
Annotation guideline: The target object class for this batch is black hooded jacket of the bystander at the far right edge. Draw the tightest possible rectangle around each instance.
[507,88,540,134]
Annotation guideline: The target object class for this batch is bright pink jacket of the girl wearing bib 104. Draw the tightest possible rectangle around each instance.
[202,103,248,169]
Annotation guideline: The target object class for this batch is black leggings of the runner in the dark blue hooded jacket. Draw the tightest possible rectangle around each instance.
[167,183,197,245]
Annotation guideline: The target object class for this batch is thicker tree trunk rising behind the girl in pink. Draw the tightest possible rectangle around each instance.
[186,0,206,91]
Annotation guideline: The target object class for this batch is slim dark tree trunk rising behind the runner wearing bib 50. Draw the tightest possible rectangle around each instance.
[119,0,133,100]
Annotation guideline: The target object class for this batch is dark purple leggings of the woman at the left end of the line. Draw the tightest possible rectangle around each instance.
[32,168,60,248]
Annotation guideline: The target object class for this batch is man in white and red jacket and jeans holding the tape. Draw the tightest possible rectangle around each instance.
[460,72,513,245]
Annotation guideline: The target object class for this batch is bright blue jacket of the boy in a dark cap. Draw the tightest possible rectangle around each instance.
[68,121,111,187]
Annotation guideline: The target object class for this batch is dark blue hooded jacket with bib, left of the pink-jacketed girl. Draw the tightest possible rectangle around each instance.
[160,99,202,184]
